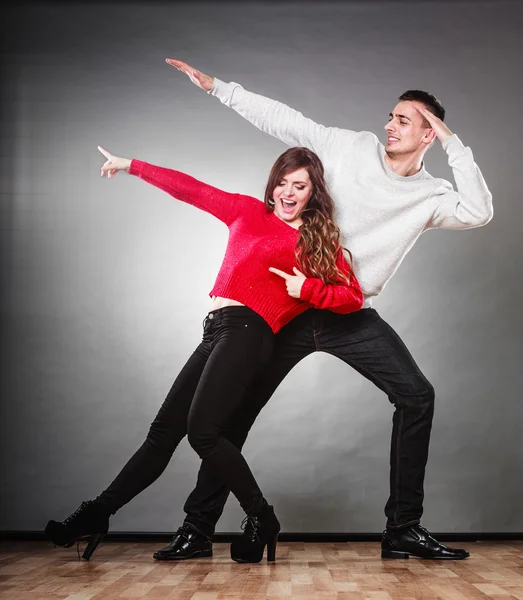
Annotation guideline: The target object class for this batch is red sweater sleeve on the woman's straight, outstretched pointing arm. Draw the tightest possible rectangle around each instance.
[129,159,254,226]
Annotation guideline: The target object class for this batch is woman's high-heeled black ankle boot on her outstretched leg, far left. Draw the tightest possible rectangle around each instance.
[45,500,111,560]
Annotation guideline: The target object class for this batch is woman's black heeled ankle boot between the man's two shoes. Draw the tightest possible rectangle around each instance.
[231,506,280,563]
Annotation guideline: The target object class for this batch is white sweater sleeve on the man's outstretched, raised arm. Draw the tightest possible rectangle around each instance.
[210,78,357,159]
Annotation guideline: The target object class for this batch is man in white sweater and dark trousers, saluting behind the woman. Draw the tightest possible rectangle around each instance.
[154,59,493,560]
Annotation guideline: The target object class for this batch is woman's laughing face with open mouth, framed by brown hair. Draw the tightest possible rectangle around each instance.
[272,168,313,228]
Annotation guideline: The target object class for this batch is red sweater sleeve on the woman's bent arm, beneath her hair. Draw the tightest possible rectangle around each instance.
[300,251,363,315]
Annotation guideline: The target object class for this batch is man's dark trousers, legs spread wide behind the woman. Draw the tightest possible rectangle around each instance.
[184,309,434,536]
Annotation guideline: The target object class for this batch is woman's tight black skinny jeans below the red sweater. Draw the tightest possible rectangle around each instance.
[96,306,274,515]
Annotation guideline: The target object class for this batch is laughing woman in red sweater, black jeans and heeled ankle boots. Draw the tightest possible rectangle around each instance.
[46,147,363,562]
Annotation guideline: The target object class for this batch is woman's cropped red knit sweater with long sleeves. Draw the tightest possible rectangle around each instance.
[129,159,363,333]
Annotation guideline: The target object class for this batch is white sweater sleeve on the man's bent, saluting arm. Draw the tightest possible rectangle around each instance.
[427,134,494,229]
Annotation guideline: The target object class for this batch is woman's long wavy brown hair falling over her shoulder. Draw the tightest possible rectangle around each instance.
[264,148,352,283]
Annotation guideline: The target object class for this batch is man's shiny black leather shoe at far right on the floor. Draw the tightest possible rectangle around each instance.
[381,525,470,560]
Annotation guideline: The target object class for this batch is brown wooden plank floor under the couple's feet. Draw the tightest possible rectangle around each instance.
[0,541,523,600]
